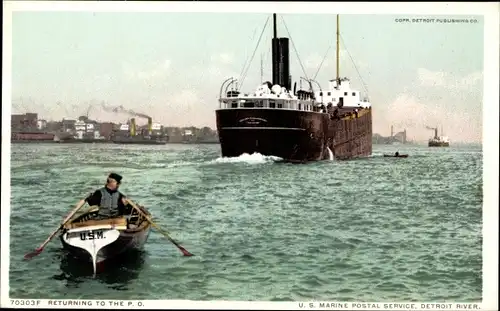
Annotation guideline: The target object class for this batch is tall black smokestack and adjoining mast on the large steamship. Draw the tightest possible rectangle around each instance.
[272,14,292,90]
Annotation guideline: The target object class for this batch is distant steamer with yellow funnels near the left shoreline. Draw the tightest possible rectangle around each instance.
[112,117,168,145]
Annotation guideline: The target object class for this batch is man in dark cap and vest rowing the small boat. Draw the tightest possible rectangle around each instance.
[85,173,133,219]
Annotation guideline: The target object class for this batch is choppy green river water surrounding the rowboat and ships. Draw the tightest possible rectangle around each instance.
[5,144,482,302]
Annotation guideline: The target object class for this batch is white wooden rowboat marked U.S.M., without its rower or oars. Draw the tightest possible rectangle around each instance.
[60,207,151,274]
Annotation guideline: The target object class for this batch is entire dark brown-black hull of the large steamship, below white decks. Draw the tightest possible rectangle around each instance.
[216,108,372,162]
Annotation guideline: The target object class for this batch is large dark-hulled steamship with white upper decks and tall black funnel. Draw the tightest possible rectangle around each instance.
[215,14,372,163]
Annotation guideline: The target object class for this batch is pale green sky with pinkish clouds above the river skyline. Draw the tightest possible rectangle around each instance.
[6,4,484,142]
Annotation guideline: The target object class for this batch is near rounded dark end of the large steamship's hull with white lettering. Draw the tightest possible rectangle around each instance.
[216,109,323,161]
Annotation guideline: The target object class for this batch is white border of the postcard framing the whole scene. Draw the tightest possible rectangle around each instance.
[0,1,499,310]
